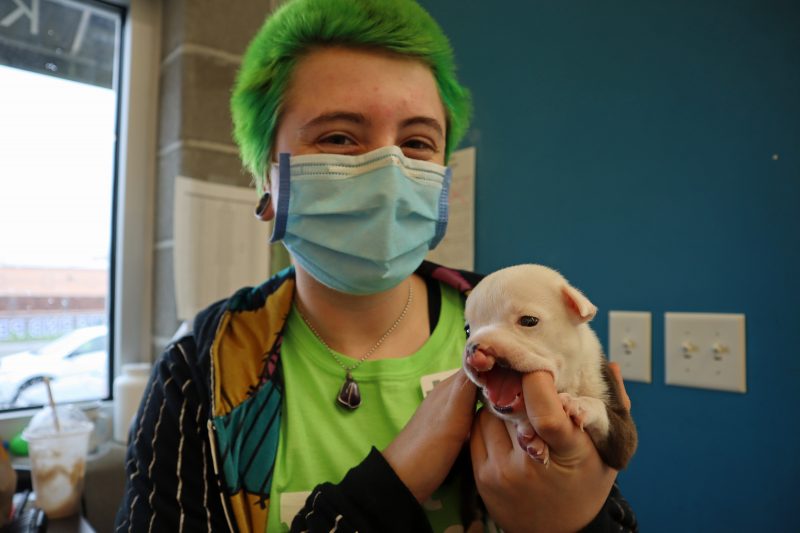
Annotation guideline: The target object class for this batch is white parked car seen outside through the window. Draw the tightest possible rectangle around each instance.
[0,326,108,408]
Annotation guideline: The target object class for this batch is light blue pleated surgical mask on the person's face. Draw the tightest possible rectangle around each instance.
[272,146,450,294]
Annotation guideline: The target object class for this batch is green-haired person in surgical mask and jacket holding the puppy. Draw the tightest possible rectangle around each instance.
[117,0,636,532]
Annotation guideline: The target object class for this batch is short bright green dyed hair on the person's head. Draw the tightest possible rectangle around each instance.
[231,0,472,194]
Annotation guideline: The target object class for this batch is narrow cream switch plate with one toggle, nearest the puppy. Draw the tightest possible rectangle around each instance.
[608,311,653,383]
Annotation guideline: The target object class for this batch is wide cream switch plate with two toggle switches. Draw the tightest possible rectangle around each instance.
[664,313,747,392]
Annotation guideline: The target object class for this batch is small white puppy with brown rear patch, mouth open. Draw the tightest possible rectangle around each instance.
[464,265,637,469]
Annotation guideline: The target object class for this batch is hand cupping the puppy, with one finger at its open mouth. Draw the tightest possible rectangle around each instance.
[470,369,630,533]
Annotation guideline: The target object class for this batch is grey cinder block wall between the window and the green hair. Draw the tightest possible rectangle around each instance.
[152,0,280,357]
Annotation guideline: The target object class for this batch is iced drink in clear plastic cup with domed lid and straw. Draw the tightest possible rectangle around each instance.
[22,406,93,518]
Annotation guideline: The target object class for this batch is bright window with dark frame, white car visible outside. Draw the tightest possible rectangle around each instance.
[0,0,125,410]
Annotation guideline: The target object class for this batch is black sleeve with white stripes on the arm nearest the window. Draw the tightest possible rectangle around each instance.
[115,337,229,533]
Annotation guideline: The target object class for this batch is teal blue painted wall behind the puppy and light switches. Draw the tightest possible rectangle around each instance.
[423,0,800,532]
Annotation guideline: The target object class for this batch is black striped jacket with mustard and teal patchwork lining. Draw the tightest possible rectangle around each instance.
[116,262,636,532]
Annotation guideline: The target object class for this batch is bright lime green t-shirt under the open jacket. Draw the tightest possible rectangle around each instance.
[267,285,465,533]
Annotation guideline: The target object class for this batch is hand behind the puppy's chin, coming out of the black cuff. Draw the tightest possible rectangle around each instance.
[383,370,476,502]
